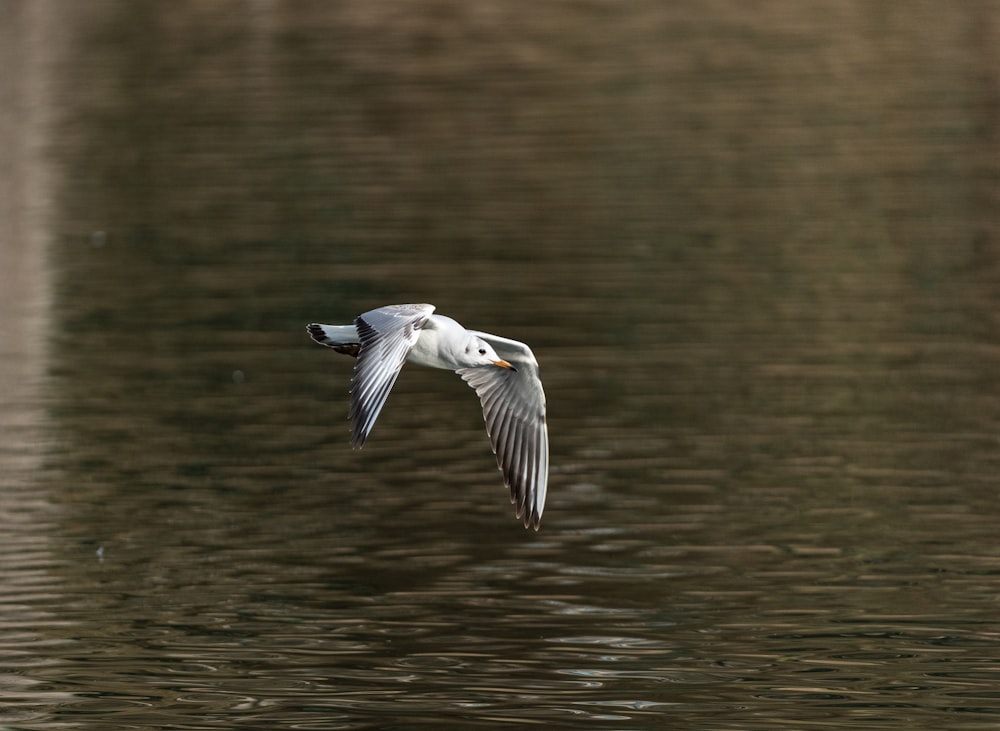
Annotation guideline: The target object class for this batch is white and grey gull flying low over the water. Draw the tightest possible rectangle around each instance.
[306,304,549,530]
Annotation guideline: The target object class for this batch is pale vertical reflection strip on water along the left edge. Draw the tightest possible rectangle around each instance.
[0,3,73,728]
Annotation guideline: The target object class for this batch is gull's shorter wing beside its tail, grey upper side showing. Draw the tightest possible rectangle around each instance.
[350,305,434,449]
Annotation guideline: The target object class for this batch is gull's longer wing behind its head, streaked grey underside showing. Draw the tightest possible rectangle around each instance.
[457,332,549,530]
